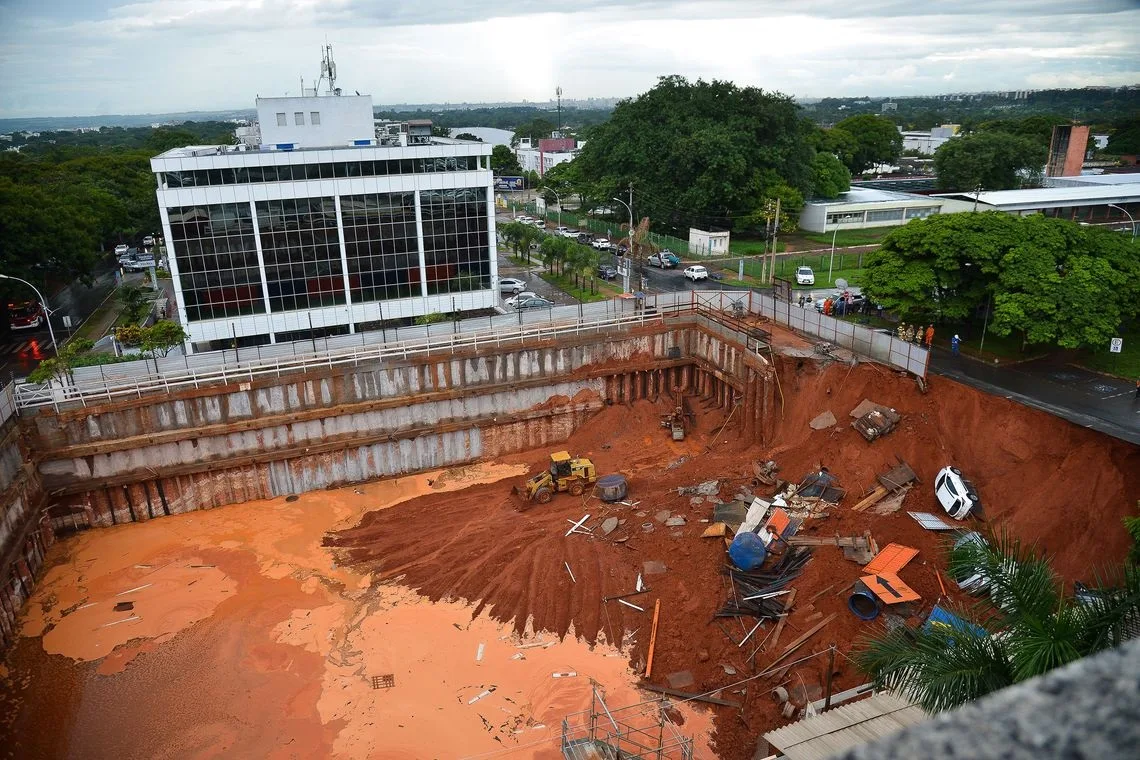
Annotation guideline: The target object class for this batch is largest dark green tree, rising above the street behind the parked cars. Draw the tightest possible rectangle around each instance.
[575,76,814,230]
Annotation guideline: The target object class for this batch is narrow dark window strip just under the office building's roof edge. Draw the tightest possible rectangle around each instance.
[163,156,479,188]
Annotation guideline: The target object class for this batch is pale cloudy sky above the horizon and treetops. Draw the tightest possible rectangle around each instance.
[0,0,1140,117]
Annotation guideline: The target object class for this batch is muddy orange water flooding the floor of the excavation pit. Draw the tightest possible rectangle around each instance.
[0,464,714,760]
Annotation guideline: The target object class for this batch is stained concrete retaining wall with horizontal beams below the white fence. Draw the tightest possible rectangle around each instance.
[30,319,766,526]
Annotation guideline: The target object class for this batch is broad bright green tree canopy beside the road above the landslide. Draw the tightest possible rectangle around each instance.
[863,212,1140,348]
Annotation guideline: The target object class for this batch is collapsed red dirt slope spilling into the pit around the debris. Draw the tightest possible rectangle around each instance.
[326,360,1140,758]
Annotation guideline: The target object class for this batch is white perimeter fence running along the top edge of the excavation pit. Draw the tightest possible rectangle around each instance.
[13,291,927,410]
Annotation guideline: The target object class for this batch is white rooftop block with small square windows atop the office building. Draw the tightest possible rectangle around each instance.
[258,95,375,147]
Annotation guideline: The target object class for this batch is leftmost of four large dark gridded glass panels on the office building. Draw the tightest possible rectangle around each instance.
[169,203,266,321]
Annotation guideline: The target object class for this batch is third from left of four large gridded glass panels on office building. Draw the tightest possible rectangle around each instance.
[341,191,421,303]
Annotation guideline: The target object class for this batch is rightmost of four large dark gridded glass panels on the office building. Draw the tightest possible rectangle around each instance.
[420,187,491,295]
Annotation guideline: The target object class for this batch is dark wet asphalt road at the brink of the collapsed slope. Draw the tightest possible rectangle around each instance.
[930,348,1140,444]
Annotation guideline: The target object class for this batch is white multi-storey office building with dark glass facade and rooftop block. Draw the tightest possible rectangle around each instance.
[150,86,498,351]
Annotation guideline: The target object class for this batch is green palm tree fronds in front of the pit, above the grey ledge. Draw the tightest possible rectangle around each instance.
[855,532,1140,712]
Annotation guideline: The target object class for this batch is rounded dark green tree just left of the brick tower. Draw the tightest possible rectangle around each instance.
[934,130,1049,191]
